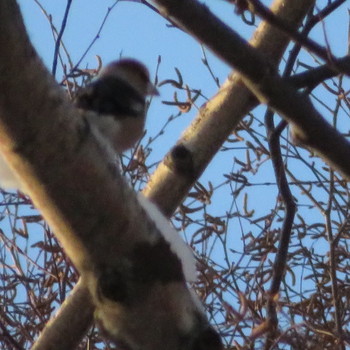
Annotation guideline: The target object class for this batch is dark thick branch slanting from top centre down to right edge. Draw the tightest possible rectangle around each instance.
[150,0,350,183]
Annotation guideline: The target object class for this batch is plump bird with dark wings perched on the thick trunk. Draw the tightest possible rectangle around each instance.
[75,59,158,153]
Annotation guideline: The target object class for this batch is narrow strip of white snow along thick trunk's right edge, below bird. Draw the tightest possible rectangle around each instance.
[137,193,197,282]
